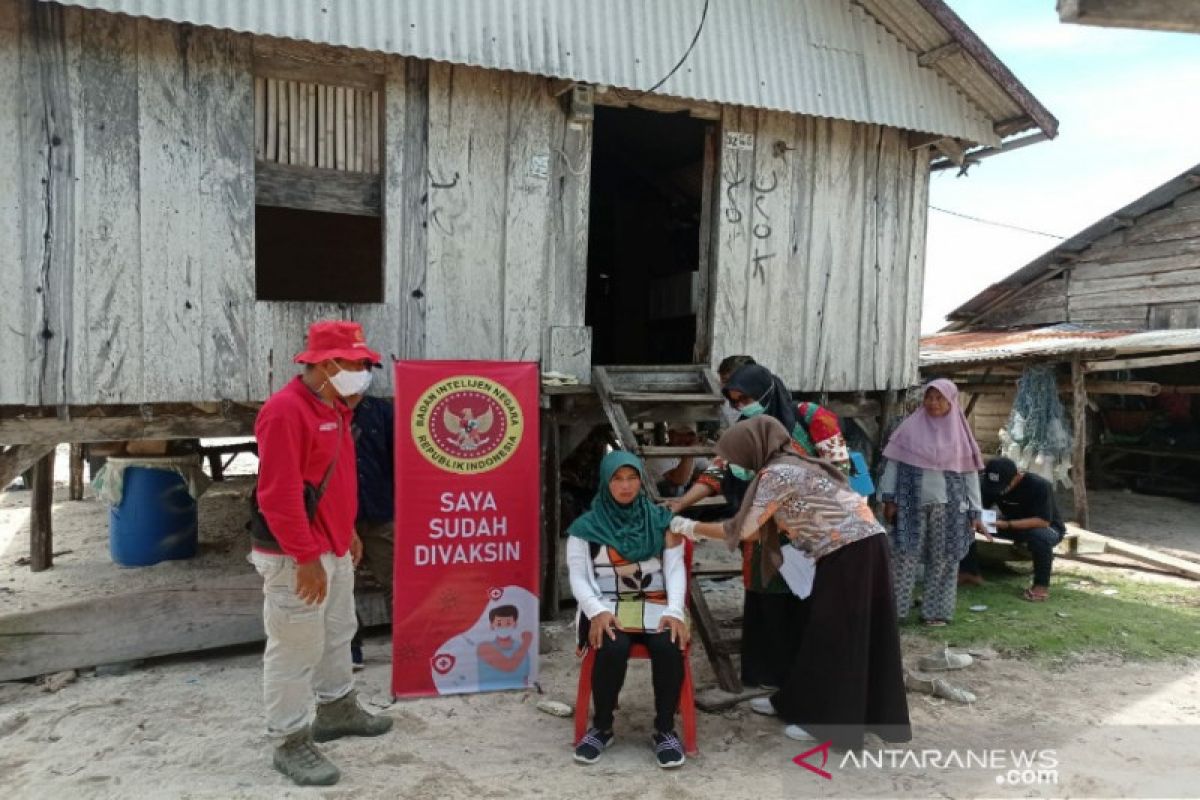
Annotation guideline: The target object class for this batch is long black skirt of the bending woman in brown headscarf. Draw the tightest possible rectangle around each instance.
[772,535,912,748]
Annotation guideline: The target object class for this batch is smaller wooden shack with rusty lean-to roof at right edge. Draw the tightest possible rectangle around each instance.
[920,164,1200,517]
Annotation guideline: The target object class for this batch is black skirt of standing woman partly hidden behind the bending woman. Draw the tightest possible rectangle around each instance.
[742,589,809,687]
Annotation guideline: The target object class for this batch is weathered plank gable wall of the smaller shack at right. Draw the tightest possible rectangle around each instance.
[1067,187,1200,327]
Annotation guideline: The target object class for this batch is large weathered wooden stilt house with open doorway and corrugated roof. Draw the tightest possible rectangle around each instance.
[0,0,1057,681]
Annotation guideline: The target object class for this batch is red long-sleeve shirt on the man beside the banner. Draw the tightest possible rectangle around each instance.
[254,377,359,564]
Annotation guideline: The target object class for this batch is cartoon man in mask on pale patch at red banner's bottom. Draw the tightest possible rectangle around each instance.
[430,587,538,694]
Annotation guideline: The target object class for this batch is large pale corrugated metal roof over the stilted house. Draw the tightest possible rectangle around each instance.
[43,0,1003,145]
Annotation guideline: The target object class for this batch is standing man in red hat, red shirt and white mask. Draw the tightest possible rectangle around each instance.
[251,321,392,786]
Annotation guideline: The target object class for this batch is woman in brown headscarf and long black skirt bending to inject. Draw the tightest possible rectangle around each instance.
[672,416,912,748]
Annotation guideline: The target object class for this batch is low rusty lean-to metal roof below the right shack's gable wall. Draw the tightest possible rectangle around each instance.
[920,325,1200,367]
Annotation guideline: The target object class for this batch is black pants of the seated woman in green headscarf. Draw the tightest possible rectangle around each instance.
[592,631,683,733]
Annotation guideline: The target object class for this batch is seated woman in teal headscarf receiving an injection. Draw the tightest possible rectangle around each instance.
[566,450,689,768]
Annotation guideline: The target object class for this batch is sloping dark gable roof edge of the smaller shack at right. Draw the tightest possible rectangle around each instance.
[947,163,1200,329]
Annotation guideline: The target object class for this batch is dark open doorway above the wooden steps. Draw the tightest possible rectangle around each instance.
[587,107,709,365]
